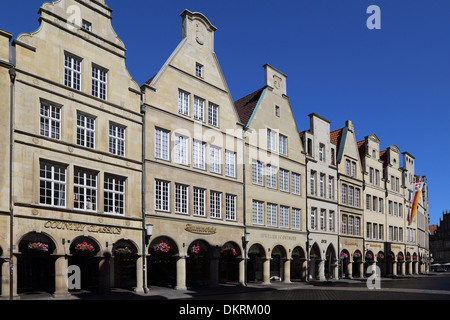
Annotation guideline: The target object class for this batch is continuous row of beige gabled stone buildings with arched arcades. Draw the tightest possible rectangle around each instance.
[0,0,429,298]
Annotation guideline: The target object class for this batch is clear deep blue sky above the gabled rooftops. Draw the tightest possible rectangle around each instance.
[0,0,450,224]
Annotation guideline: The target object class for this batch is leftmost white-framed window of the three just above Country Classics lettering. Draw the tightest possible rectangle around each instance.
[39,161,67,207]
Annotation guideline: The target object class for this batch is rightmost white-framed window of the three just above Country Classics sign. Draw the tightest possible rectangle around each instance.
[103,175,125,215]
